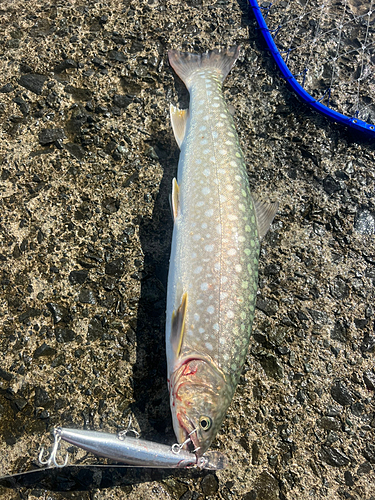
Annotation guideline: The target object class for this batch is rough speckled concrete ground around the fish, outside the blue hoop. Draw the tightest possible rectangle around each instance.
[0,0,375,500]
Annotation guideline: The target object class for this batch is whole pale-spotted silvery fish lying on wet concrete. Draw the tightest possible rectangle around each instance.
[166,46,278,456]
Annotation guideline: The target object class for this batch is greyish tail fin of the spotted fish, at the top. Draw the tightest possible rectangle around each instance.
[168,46,240,89]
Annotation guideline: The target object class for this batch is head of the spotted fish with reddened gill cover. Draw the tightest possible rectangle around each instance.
[170,359,231,457]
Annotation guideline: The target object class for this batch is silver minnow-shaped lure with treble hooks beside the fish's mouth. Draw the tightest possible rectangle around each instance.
[39,427,227,469]
